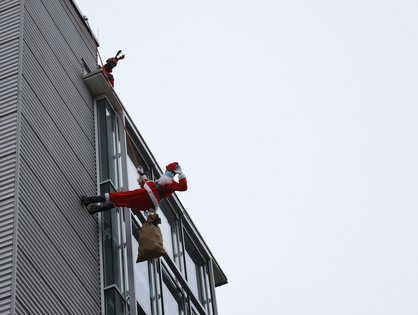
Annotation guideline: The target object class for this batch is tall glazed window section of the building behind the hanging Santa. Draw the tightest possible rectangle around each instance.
[87,76,225,315]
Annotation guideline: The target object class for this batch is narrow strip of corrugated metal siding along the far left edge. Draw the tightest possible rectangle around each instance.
[0,0,20,314]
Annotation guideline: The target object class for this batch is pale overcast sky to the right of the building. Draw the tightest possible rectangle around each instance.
[76,0,418,315]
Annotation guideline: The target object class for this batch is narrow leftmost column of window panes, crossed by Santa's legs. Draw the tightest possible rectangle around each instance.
[96,99,127,315]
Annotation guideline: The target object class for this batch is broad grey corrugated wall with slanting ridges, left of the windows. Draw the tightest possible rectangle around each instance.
[16,0,101,314]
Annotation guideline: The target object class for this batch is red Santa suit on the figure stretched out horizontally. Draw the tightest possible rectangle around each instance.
[105,169,187,211]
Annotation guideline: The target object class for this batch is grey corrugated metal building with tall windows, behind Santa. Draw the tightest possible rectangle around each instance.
[0,0,227,315]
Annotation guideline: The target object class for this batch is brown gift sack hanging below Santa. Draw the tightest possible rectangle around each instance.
[136,213,165,262]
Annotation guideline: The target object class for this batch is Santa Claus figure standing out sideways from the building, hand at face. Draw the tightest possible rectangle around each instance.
[81,162,187,214]
